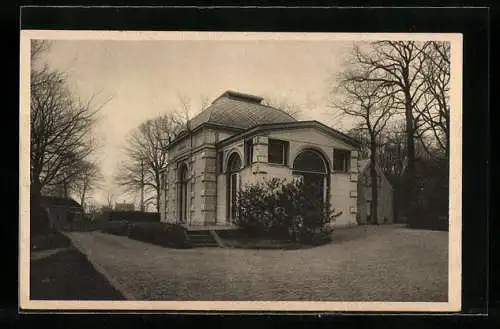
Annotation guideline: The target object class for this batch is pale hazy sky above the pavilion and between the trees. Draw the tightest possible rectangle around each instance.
[40,40,360,203]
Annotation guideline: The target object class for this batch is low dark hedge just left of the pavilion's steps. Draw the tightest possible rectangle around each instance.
[128,222,191,248]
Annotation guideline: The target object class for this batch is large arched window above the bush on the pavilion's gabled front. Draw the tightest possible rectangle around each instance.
[293,149,329,205]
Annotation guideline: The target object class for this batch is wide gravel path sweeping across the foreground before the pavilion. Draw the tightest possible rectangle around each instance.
[64,226,448,302]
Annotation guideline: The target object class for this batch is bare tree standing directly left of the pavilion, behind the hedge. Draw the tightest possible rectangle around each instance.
[115,114,178,211]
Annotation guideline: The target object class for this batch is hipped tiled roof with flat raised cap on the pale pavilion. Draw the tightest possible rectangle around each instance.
[189,90,297,130]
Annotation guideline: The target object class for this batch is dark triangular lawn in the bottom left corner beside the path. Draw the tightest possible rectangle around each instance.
[30,243,124,300]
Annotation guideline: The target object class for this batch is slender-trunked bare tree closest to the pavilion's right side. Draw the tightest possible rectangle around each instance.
[332,76,395,224]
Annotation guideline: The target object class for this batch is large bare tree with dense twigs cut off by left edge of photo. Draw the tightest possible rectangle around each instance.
[30,41,104,208]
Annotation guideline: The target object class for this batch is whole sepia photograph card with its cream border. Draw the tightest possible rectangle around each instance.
[19,30,462,312]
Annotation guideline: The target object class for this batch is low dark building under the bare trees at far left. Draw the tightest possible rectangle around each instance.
[40,196,83,229]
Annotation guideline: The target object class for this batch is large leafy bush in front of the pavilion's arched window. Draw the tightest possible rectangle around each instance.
[235,178,340,243]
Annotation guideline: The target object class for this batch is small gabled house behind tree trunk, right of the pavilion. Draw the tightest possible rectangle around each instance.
[357,160,394,224]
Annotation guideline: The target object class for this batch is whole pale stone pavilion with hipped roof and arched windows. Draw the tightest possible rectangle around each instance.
[160,91,359,226]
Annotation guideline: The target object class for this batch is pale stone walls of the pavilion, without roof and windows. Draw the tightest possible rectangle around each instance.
[160,124,358,227]
